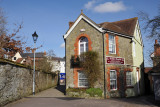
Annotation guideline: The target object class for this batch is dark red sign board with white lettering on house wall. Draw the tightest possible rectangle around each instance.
[106,56,124,65]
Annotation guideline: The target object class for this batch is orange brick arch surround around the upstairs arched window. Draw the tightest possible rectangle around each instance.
[74,33,92,57]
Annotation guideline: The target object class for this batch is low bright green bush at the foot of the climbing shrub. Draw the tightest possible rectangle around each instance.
[86,88,103,97]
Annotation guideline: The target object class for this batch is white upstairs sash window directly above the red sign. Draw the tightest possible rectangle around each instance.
[109,35,116,54]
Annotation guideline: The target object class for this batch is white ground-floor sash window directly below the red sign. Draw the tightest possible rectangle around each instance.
[110,70,117,90]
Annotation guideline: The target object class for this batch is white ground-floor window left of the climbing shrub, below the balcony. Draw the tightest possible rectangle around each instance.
[78,71,88,87]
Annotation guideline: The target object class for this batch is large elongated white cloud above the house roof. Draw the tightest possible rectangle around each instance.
[93,1,127,13]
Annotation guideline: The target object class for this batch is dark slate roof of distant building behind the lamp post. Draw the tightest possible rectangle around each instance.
[21,52,45,58]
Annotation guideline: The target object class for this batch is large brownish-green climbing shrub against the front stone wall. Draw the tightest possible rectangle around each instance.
[80,51,101,88]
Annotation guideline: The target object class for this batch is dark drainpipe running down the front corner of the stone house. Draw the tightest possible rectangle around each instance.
[102,29,106,99]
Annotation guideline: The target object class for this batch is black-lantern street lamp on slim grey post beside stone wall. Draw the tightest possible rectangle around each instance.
[32,31,38,95]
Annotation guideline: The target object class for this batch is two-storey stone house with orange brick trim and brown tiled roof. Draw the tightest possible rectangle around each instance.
[63,11,144,98]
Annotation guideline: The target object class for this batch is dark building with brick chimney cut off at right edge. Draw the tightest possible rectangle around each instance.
[146,40,160,101]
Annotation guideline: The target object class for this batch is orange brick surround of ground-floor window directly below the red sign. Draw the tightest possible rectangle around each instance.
[107,67,120,91]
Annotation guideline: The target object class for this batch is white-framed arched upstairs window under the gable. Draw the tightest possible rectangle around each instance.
[79,37,88,54]
